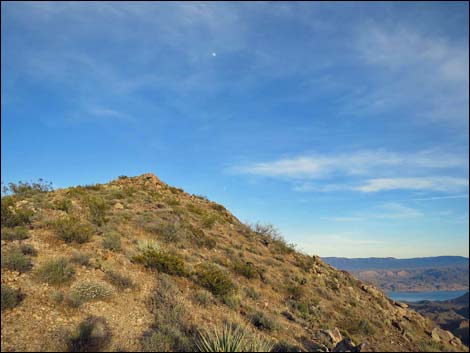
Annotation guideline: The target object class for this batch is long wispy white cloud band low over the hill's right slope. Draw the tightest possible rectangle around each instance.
[230,150,468,193]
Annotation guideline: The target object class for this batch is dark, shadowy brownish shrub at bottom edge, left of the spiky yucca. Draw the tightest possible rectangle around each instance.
[67,316,111,352]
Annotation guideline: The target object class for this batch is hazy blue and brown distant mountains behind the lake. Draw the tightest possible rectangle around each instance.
[323,256,469,292]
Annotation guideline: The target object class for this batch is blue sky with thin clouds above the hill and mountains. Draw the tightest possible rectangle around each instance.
[1,2,469,258]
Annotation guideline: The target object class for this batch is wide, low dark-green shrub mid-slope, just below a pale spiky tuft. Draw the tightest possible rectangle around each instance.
[133,250,187,276]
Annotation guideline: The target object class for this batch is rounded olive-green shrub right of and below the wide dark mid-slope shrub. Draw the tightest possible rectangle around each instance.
[196,263,235,297]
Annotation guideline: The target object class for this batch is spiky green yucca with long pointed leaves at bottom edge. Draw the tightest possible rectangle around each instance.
[196,324,274,352]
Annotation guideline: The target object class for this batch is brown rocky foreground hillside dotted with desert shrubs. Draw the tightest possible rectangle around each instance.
[1,174,468,352]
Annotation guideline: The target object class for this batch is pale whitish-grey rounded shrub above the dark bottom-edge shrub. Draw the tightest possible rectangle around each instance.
[66,280,113,307]
